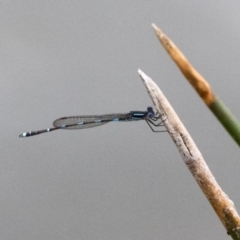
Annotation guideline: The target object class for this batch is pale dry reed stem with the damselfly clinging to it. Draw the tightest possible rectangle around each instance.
[138,70,240,239]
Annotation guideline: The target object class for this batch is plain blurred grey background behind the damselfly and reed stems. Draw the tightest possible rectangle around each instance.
[0,0,240,240]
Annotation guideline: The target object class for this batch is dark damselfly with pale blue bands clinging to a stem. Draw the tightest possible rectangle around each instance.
[19,107,166,137]
